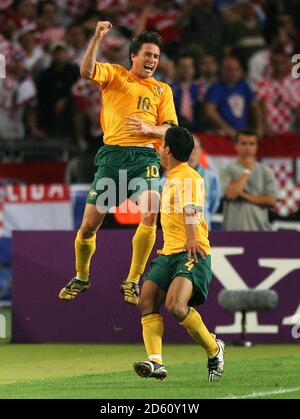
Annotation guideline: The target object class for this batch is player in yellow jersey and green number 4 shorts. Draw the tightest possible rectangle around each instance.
[133,127,224,381]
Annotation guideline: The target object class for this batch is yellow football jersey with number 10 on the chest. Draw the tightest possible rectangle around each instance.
[93,62,177,146]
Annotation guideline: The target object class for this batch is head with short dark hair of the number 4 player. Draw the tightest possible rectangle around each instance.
[165,126,194,162]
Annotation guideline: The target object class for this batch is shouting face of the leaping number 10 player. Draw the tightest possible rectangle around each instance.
[131,44,160,79]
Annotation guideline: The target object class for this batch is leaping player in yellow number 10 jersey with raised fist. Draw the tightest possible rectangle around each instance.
[59,22,177,304]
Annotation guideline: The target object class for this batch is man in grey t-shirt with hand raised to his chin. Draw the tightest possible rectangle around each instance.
[220,129,277,231]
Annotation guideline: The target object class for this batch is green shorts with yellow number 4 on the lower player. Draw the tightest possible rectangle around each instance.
[144,252,212,306]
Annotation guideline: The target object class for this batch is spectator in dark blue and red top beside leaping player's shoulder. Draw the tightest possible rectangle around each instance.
[172,55,200,131]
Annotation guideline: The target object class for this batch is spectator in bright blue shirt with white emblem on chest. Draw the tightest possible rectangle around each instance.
[206,57,262,139]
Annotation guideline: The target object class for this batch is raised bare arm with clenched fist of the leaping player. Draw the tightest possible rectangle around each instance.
[80,21,112,80]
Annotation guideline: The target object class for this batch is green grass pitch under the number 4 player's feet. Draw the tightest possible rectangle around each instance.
[0,310,300,399]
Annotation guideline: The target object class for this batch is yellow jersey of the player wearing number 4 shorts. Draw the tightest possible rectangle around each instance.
[159,163,210,255]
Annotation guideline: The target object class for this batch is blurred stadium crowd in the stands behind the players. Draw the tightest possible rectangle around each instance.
[0,0,300,228]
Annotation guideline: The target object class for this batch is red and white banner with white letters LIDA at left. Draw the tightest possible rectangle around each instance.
[0,184,73,237]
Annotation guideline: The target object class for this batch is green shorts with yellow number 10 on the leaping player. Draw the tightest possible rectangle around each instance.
[86,145,160,209]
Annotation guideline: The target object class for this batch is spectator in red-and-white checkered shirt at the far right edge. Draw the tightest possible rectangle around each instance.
[255,48,300,137]
